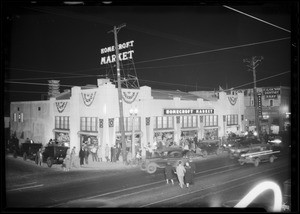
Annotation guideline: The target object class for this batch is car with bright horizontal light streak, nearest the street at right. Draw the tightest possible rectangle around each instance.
[238,145,280,167]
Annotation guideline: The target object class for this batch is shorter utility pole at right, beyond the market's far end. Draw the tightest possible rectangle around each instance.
[243,56,264,139]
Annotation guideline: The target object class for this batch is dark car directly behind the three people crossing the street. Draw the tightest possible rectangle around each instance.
[140,147,188,174]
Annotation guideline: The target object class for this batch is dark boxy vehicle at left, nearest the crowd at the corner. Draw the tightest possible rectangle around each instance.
[43,145,69,167]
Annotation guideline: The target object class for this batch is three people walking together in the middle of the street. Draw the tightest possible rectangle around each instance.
[165,159,196,188]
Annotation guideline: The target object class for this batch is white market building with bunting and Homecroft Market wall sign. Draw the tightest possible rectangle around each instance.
[10,79,245,156]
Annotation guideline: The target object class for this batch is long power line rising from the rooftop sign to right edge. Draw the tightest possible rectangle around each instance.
[136,37,290,64]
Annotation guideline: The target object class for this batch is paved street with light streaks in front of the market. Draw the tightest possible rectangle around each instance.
[6,153,290,209]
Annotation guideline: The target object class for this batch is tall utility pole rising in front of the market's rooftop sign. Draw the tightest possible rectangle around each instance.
[108,24,127,163]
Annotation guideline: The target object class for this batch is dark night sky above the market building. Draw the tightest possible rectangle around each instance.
[2,1,292,105]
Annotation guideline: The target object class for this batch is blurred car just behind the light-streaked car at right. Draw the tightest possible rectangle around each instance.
[229,138,265,159]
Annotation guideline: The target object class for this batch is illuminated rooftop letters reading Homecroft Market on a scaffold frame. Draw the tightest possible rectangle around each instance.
[100,40,134,65]
